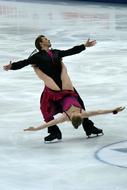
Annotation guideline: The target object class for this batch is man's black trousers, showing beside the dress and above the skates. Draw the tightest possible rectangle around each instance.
[48,89,94,134]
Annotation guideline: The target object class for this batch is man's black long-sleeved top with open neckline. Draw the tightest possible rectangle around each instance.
[11,44,85,89]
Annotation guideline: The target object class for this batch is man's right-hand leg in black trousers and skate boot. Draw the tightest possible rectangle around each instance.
[74,89,103,137]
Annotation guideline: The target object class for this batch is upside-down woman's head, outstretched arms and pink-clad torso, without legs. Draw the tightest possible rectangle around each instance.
[24,90,125,131]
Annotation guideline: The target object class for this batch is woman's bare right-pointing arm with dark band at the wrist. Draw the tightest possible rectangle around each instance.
[82,107,125,118]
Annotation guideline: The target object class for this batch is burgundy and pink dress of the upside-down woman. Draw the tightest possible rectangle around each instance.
[40,86,81,122]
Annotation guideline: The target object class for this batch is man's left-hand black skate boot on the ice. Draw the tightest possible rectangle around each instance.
[44,132,62,143]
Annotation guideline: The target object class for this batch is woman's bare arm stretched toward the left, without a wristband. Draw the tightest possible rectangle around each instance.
[24,113,68,131]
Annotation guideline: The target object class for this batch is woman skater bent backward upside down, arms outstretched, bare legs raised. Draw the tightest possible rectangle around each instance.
[24,63,125,131]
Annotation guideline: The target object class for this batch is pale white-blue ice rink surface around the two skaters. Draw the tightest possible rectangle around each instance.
[0,1,127,190]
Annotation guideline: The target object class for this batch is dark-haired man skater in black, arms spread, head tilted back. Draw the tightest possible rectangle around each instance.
[4,35,102,141]
